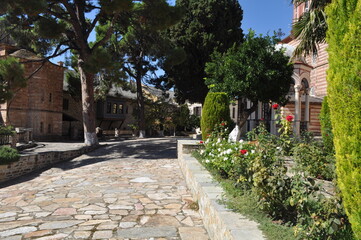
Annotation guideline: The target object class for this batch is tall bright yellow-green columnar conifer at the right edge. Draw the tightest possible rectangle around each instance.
[326,0,361,236]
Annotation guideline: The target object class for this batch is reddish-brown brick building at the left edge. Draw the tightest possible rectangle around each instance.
[0,43,64,140]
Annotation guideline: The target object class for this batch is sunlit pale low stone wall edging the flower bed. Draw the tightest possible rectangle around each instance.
[178,140,265,240]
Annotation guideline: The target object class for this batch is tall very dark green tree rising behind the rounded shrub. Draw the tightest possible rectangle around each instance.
[157,0,243,102]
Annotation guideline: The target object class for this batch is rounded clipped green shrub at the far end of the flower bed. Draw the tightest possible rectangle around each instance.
[201,92,231,139]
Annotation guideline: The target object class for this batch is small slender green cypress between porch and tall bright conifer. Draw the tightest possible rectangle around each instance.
[320,96,335,152]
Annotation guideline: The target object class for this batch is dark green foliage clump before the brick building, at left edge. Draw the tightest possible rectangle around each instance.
[0,57,27,103]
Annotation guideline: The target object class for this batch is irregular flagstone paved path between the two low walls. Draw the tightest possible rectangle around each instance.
[0,139,208,240]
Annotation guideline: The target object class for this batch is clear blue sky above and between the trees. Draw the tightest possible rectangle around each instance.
[51,0,292,63]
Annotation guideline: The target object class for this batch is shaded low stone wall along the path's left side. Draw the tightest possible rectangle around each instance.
[0,146,99,183]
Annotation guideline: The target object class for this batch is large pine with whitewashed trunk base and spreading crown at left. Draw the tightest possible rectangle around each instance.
[0,0,133,145]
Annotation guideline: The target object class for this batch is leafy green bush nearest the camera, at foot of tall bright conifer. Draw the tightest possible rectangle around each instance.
[290,174,354,240]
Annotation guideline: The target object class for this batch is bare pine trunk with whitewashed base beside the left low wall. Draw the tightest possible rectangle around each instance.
[78,57,98,146]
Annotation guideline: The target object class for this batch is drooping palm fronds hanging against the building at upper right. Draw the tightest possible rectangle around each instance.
[292,0,331,57]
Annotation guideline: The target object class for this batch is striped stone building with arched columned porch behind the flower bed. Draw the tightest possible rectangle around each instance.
[276,1,328,134]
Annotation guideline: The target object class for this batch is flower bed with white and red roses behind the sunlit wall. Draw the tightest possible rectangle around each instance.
[194,122,353,240]
